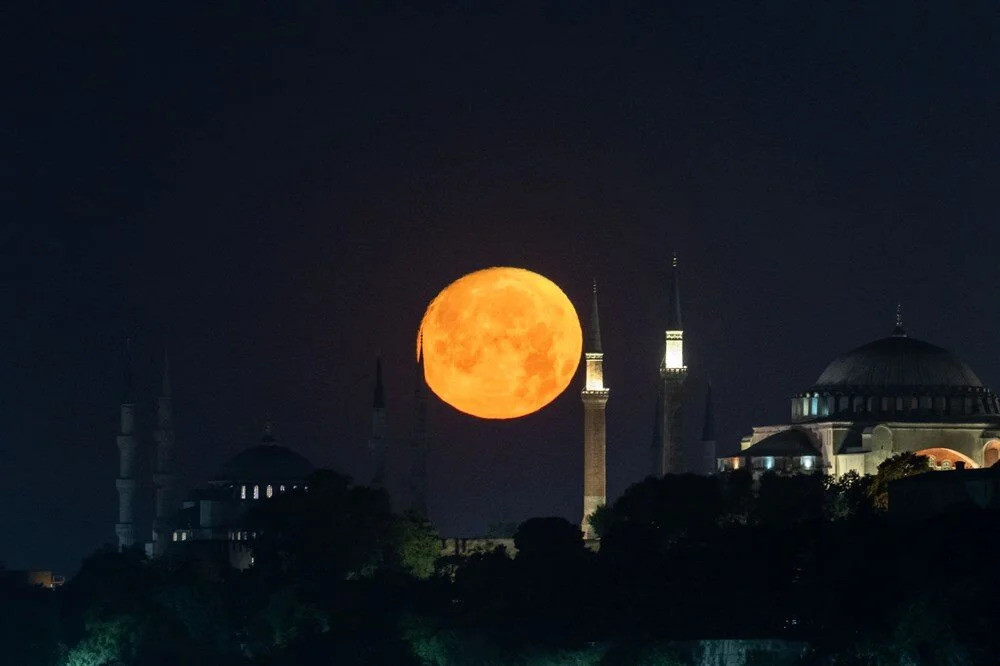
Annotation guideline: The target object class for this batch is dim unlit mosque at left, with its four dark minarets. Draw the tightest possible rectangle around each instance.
[115,344,427,569]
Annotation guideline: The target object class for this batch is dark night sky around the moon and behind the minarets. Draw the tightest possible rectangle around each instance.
[0,1,1000,574]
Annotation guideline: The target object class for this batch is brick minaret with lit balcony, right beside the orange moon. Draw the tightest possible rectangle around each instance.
[580,280,610,539]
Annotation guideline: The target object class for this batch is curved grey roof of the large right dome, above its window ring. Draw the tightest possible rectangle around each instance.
[810,334,983,391]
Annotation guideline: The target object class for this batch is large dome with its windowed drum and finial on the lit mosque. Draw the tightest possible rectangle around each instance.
[792,321,1000,421]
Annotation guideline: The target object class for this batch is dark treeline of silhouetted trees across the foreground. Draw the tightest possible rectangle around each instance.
[0,456,1000,666]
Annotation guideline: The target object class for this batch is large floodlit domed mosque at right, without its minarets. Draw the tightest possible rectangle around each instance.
[719,312,1000,477]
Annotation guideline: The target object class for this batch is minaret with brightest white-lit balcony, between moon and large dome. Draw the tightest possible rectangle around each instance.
[653,253,687,476]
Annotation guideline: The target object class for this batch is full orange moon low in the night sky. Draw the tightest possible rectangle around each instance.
[417,267,583,419]
